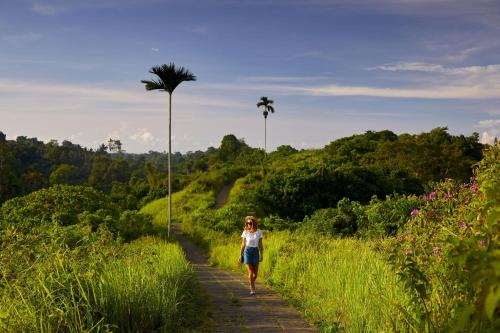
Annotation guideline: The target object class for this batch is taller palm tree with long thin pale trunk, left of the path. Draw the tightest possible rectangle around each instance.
[141,63,196,237]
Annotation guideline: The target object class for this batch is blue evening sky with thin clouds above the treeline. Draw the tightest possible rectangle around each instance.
[0,0,500,152]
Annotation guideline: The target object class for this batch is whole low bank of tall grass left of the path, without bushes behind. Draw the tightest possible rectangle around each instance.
[0,231,200,332]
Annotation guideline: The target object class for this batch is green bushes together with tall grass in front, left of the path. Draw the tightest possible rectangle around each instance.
[0,185,205,332]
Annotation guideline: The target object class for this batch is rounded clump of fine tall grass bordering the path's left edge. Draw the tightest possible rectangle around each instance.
[89,238,195,332]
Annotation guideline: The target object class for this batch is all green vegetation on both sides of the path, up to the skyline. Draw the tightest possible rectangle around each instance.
[0,128,492,332]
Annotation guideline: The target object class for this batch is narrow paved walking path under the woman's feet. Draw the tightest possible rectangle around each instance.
[172,225,317,333]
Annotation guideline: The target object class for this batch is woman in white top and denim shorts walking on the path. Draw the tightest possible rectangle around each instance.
[238,216,264,295]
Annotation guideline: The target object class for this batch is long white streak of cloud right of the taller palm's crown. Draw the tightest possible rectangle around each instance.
[201,62,500,99]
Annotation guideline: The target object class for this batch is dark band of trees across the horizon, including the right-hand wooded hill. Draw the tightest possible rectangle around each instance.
[0,128,483,210]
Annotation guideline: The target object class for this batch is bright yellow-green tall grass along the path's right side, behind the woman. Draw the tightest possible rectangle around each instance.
[183,225,408,332]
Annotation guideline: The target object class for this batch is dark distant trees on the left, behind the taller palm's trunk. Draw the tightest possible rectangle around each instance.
[0,132,217,205]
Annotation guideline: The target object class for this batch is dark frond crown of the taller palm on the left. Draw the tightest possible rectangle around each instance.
[141,63,196,94]
